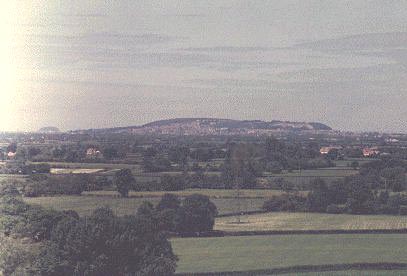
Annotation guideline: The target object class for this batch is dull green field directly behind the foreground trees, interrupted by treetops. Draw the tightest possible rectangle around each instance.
[24,196,264,216]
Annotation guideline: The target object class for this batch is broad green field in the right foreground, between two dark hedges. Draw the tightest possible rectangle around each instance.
[171,234,407,275]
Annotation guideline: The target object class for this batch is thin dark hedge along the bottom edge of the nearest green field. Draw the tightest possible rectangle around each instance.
[175,263,407,276]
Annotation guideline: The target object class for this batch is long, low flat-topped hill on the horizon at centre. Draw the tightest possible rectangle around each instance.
[74,118,332,135]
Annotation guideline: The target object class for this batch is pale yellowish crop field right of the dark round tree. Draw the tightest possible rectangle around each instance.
[215,212,407,233]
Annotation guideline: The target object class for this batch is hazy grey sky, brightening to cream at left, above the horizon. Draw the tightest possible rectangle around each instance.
[0,0,407,132]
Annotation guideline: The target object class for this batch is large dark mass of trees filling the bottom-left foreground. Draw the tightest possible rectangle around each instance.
[0,185,217,276]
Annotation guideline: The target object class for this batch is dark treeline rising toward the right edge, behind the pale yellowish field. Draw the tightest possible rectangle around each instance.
[263,159,407,215]
